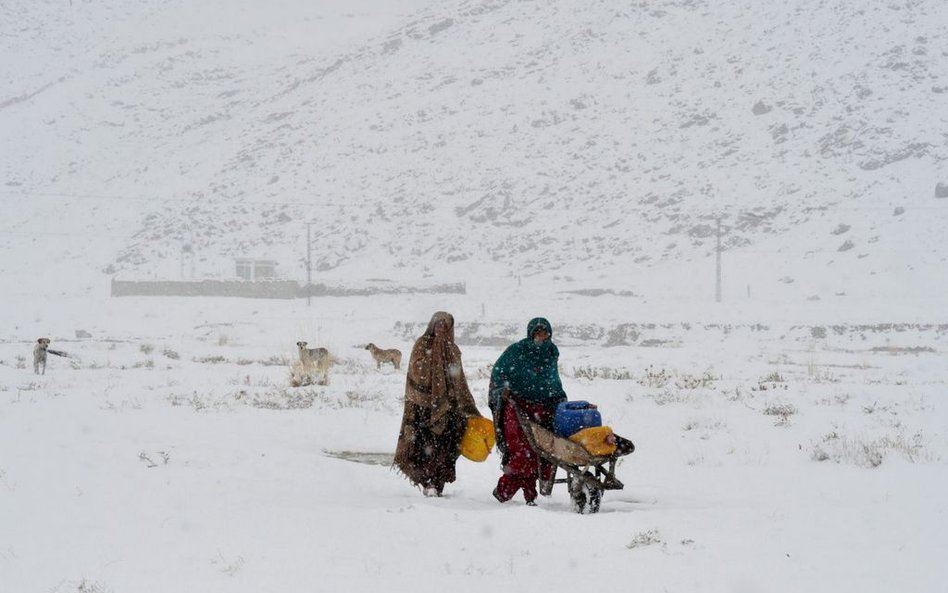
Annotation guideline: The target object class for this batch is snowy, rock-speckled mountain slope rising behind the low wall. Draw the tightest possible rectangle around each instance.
[0,0,948,302]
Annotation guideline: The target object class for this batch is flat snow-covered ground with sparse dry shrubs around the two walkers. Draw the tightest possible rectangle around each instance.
[0,292,948,593]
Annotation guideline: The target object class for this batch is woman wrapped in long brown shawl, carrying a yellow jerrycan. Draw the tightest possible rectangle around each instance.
[395,311,481,496]
